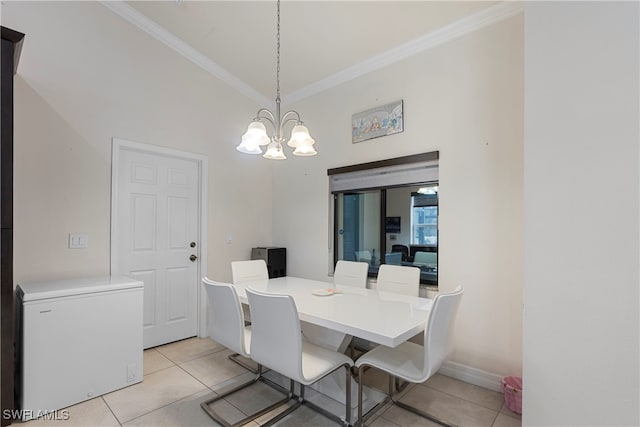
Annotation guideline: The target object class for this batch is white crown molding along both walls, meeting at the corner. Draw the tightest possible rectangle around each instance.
[100,0,524,105]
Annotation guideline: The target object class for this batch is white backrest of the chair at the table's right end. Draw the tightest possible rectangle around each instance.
[424,286,464,379]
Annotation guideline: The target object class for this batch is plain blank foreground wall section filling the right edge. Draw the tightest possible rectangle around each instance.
[523,2,640,426]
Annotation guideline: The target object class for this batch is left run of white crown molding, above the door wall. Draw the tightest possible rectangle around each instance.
[100,0,273,105]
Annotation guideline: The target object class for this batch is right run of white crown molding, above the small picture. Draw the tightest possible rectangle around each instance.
[282,1,524,104]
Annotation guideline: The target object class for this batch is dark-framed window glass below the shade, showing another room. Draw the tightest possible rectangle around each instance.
[334,182,438,285]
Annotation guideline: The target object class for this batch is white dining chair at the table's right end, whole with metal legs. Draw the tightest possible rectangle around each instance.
[356,287,463,426]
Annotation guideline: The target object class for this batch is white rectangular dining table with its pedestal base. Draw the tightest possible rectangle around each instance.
[228,276,433,413]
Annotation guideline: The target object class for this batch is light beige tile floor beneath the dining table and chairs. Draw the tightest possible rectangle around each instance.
[16,338,521,427]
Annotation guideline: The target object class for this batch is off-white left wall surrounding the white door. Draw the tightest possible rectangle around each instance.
[2,2,272,283]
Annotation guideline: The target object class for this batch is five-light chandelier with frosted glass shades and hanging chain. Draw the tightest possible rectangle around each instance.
[236,0,318,160]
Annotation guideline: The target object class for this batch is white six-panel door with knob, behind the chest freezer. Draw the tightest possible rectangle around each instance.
[111,144,201,348]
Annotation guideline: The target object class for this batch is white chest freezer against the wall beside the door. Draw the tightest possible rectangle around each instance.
[16,276,144,421]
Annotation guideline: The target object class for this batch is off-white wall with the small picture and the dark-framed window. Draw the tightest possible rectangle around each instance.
[273,16,523,375]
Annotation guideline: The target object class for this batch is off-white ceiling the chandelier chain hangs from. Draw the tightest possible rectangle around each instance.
[116,0,501,102]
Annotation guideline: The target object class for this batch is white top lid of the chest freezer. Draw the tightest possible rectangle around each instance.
[16,276,144,302]
